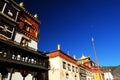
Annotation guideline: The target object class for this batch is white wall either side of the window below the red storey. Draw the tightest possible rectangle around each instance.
[14,33,38,50]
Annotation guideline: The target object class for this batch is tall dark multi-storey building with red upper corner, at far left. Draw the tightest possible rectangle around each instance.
[0,0,48,80]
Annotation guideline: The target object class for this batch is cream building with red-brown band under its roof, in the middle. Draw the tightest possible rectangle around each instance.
[47,44,79,80]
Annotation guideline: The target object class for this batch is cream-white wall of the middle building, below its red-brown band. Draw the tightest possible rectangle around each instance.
[49,57,80,80]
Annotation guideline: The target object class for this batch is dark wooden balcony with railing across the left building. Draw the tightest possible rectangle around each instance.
[0,40,48,70]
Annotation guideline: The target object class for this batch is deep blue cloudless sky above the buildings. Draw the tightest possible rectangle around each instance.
[16,0,120,66]
